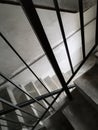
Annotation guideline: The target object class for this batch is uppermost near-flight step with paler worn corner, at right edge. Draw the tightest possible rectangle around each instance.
[74,64,98,108]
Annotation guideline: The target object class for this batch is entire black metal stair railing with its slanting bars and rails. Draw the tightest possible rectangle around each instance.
[0,0,98,129]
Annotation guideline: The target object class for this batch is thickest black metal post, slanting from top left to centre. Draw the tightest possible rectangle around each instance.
[20,0,72,99]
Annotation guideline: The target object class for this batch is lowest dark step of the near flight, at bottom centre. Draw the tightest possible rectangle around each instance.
[44,111,74,130]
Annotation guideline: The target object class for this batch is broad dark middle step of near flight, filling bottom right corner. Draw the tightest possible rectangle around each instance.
[62,89,98,130]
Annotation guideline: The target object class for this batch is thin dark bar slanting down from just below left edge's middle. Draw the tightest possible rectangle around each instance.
[0,73,46,109]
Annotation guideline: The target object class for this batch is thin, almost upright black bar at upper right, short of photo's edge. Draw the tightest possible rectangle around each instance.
[79,0,85,59]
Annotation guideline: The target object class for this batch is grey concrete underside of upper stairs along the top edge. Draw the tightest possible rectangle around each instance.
[0,0,96,13]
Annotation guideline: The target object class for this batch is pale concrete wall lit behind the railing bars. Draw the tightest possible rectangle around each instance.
[0,5,96,85]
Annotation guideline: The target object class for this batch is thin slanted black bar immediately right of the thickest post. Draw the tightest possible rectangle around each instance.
[53,0,74,74]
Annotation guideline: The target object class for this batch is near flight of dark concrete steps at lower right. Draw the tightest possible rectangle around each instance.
[37,59,98,130]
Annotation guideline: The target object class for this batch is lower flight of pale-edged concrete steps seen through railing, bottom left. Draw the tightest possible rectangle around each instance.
[0,70,68,130]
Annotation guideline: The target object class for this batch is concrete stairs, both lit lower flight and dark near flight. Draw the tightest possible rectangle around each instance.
[0,56,98,130]
